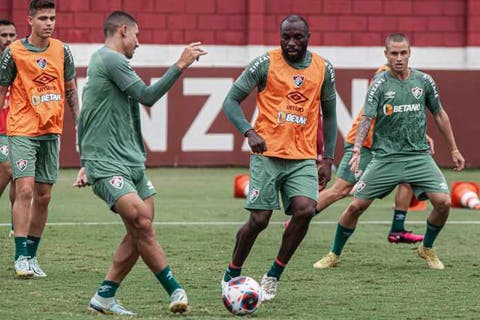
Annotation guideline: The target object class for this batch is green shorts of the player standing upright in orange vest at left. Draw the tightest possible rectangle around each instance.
[8,136,59,184]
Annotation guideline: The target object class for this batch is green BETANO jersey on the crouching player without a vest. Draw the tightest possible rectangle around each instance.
[363,69,442,160]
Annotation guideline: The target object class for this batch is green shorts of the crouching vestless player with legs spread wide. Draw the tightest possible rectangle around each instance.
[354,154,449,200]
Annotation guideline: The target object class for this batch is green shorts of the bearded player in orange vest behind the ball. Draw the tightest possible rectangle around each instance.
[245,155,318,214]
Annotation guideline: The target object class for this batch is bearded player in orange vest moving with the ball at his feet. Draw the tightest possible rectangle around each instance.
[222,15,337,301]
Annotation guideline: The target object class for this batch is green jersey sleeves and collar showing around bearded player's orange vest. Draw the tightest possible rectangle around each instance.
[233,51,336,101]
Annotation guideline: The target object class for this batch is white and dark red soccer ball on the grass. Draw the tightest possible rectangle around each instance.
[222,277,262,316]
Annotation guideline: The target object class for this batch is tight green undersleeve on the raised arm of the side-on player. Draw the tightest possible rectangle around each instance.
[125,65,182,106]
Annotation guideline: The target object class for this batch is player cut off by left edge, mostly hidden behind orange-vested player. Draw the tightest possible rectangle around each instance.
[0,19,17,237]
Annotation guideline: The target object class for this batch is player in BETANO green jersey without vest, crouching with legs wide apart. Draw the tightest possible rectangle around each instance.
[316,33,465,270]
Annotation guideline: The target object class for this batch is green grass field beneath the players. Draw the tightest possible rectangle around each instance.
[0,168,480,320]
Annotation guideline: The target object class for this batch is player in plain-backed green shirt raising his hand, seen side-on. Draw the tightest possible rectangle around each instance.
[74,11,206,316]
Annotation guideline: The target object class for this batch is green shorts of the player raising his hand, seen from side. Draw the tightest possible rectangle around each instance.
[84,160,157,210]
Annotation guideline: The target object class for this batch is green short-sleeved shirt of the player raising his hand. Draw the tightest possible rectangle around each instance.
[78,47,146,166]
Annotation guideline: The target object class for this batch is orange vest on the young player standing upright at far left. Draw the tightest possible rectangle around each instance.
[7,38,65,137]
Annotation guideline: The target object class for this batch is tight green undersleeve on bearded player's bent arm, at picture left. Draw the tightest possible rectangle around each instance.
[223,85,253,135]
